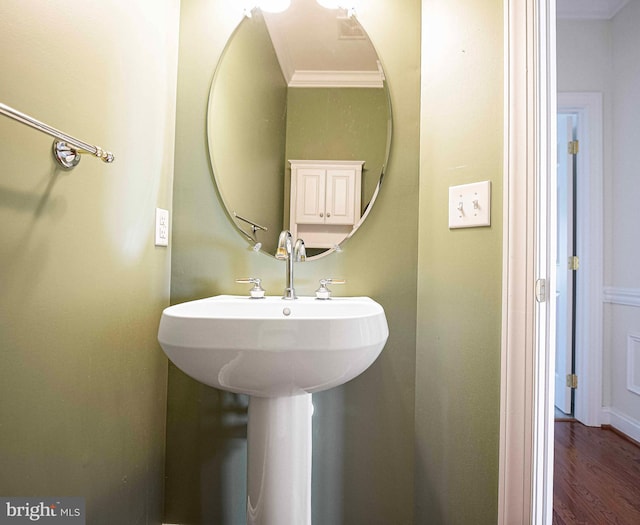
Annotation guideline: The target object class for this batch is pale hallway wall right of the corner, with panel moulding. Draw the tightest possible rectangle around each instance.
[605,0,640,439]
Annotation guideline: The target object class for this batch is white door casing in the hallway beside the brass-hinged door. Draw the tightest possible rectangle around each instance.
[557,92,604,426]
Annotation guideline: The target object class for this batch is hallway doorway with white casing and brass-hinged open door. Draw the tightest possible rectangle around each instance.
[554,92,604,426]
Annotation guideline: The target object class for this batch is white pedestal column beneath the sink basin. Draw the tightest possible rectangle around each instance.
[247,394,313,525]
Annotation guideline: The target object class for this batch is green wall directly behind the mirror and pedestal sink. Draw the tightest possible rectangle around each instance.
[165,0,420,525]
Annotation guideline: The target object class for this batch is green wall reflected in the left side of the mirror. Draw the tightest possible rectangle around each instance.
[207,12,287,252]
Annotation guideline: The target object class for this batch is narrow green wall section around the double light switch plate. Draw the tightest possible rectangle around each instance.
[415,0,503,525]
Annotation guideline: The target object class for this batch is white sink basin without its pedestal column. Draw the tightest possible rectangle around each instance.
[158,295,389,397]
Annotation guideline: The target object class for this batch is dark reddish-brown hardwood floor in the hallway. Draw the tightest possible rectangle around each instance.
[553,421,640,525]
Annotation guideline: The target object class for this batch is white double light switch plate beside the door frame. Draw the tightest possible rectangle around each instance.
[449,181,491,229]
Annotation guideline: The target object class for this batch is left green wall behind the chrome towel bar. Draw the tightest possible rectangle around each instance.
[0,0,179,525]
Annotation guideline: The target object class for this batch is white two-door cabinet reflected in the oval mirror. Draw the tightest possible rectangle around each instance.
[289,160,364,249]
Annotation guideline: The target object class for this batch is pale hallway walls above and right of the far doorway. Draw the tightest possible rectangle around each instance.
[557,1,640,439]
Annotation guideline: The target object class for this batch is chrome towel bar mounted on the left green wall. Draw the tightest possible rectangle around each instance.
[0,102,114,169]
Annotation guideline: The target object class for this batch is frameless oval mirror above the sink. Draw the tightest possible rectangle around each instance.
[207,0,391,258]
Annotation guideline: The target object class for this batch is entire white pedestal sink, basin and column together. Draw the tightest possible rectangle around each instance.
[158,295,389,525]
